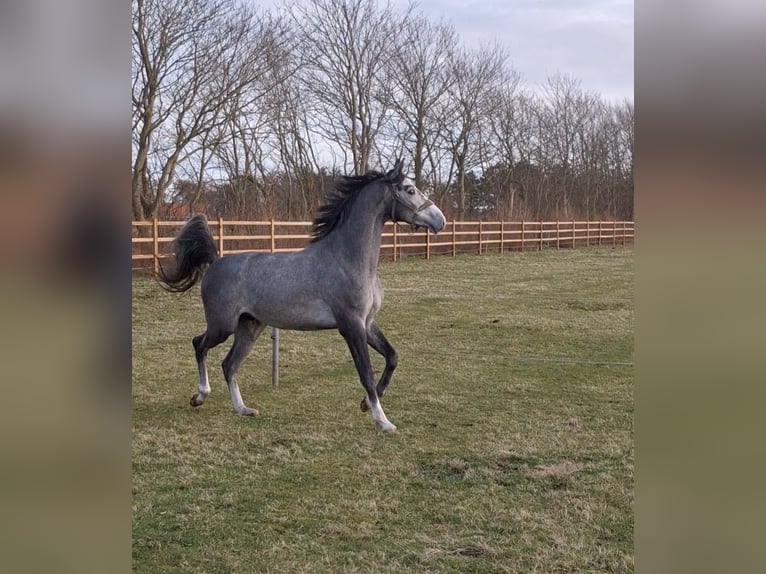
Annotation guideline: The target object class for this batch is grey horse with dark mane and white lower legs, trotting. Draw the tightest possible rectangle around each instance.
[158,160,446,432]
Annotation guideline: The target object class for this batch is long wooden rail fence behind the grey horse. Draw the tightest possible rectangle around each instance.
[132,219,635,271]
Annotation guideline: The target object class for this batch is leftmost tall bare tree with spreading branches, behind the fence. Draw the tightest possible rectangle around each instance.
[132,0,282,219]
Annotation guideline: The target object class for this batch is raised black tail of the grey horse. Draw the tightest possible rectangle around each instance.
[157,214,218,293]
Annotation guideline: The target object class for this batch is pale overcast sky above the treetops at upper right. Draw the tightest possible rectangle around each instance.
[392,0,633,102]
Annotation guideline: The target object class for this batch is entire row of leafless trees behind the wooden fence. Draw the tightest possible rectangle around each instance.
[132,0,633,224]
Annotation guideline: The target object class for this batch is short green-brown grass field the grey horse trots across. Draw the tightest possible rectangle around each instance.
[133,248,634,574]
